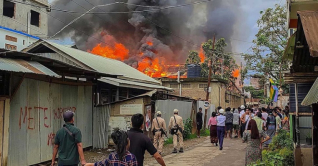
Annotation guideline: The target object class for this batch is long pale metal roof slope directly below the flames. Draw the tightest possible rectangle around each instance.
[44,41,160,84]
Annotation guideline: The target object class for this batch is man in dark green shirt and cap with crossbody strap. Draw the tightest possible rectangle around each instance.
[51,110,86,166]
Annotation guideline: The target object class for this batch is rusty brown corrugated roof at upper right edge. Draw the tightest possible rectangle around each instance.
[297,11,318,57]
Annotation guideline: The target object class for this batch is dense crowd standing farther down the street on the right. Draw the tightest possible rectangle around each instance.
[204,105,289,165]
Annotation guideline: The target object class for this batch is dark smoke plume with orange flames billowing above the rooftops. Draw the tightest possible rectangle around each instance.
[49,0,242,67]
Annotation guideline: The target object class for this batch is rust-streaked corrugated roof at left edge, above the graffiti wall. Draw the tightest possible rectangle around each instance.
[0,58,60,77]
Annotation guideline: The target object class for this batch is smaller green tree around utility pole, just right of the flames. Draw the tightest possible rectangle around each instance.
[201,38,238,79]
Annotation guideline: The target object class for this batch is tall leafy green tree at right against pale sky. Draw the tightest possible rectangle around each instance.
[243,5,289,93]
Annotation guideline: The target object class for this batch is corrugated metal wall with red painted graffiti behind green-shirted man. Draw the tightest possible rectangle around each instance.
[8,79,92,166]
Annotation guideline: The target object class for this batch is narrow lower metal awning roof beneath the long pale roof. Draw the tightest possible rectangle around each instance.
[98,77,172,91]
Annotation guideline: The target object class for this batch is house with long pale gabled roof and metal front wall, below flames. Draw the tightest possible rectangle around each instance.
[24,40,193,148]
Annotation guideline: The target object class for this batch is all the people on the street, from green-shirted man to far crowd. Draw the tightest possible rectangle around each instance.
[52,105,289,166]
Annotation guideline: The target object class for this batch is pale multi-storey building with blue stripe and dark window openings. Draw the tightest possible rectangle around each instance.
[0,0,49,51]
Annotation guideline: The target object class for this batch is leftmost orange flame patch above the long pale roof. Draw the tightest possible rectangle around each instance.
[90,43,129,61]
